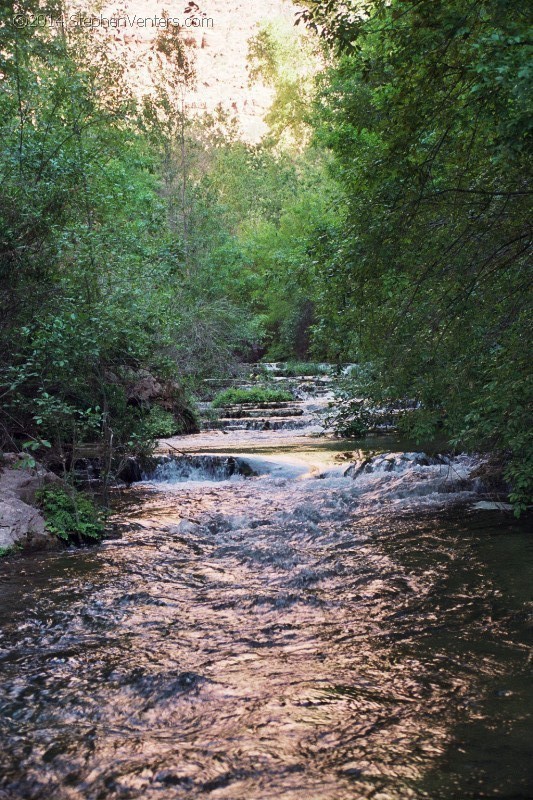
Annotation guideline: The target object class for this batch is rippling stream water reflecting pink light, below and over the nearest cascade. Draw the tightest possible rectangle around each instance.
[0,412,533,800]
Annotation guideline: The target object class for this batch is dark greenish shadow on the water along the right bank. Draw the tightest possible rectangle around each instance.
[374,512,533,800]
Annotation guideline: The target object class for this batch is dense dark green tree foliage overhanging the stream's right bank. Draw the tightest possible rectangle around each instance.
[303,0,533,508]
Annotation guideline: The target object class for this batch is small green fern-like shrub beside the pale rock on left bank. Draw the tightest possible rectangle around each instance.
[36,486,105,544]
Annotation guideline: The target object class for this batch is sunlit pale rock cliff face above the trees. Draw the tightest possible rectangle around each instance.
[89,0,296,142]
